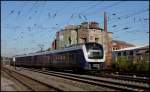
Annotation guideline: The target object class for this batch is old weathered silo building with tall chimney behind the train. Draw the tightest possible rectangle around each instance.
[52,13,112,67]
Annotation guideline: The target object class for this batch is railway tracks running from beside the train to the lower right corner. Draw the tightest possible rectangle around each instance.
[21,69,149,91]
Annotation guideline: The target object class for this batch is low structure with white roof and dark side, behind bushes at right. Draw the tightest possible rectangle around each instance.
[112,46,149,62]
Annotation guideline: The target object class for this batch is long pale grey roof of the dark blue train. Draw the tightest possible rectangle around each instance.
[14,44,84,57]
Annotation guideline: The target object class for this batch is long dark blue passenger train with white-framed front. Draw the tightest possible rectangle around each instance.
[10,42,105,71]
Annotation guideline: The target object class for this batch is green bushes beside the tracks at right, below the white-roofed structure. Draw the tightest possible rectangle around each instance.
[111,57,150,72]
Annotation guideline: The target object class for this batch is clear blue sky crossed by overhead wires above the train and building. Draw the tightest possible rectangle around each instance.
[1,1,149,57]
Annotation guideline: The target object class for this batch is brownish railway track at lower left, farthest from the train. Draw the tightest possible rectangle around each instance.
[2,67,62,91]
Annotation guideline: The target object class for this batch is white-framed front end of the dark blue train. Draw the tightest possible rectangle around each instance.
[83,43,105,70]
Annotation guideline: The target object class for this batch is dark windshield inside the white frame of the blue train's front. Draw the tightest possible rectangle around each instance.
[86,43,103,59]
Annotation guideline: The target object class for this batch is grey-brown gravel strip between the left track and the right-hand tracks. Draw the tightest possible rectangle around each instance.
[5,66,114,91]
